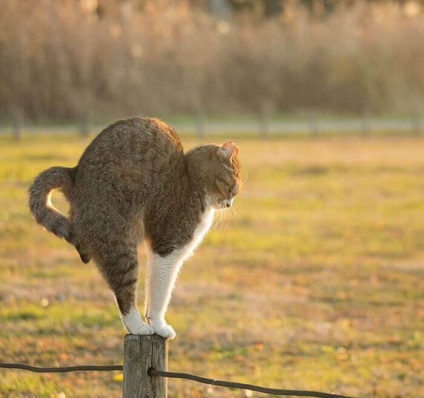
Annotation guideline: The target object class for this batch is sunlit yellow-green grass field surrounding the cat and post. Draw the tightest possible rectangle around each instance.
[0,131,424,398]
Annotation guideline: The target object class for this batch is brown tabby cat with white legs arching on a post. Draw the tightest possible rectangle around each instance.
[29,118,241,338]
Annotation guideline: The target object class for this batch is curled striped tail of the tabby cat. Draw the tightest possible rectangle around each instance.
[29,167,75,243]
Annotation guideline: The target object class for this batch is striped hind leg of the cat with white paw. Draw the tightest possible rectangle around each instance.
[97,247,154,335]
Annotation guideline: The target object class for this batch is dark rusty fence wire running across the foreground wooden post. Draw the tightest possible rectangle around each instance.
[0,362,357,398]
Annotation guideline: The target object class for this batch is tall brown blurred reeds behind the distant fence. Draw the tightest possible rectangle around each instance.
[0,0,424,134]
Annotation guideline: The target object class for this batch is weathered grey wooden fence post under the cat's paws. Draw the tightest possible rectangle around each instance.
[123,334,168,398]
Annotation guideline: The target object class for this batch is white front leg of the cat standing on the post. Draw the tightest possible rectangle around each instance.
[146,250,182,339]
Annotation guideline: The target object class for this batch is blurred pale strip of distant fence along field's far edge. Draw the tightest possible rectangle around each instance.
[0,113,424,139]
